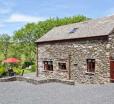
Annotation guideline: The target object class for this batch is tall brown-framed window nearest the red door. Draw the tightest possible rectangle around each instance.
[87,59,95,72]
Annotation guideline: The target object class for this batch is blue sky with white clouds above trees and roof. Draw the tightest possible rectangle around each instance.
[0,0,114,35]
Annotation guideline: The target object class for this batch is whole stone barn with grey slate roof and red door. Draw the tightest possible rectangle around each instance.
[36,16,114,83]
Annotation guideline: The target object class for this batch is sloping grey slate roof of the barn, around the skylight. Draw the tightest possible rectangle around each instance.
[36,15,114,43]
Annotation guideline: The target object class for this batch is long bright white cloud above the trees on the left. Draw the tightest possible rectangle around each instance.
[6,14,46,22]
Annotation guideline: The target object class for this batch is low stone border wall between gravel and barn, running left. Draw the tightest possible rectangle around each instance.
[0,76,75,85]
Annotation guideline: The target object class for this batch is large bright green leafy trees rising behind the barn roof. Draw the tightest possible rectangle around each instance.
[13,15,89,59]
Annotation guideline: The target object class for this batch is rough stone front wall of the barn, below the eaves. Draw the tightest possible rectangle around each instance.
[38,36,110,83]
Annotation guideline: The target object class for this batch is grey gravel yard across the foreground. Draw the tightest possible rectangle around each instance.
[0,81,114,104]
